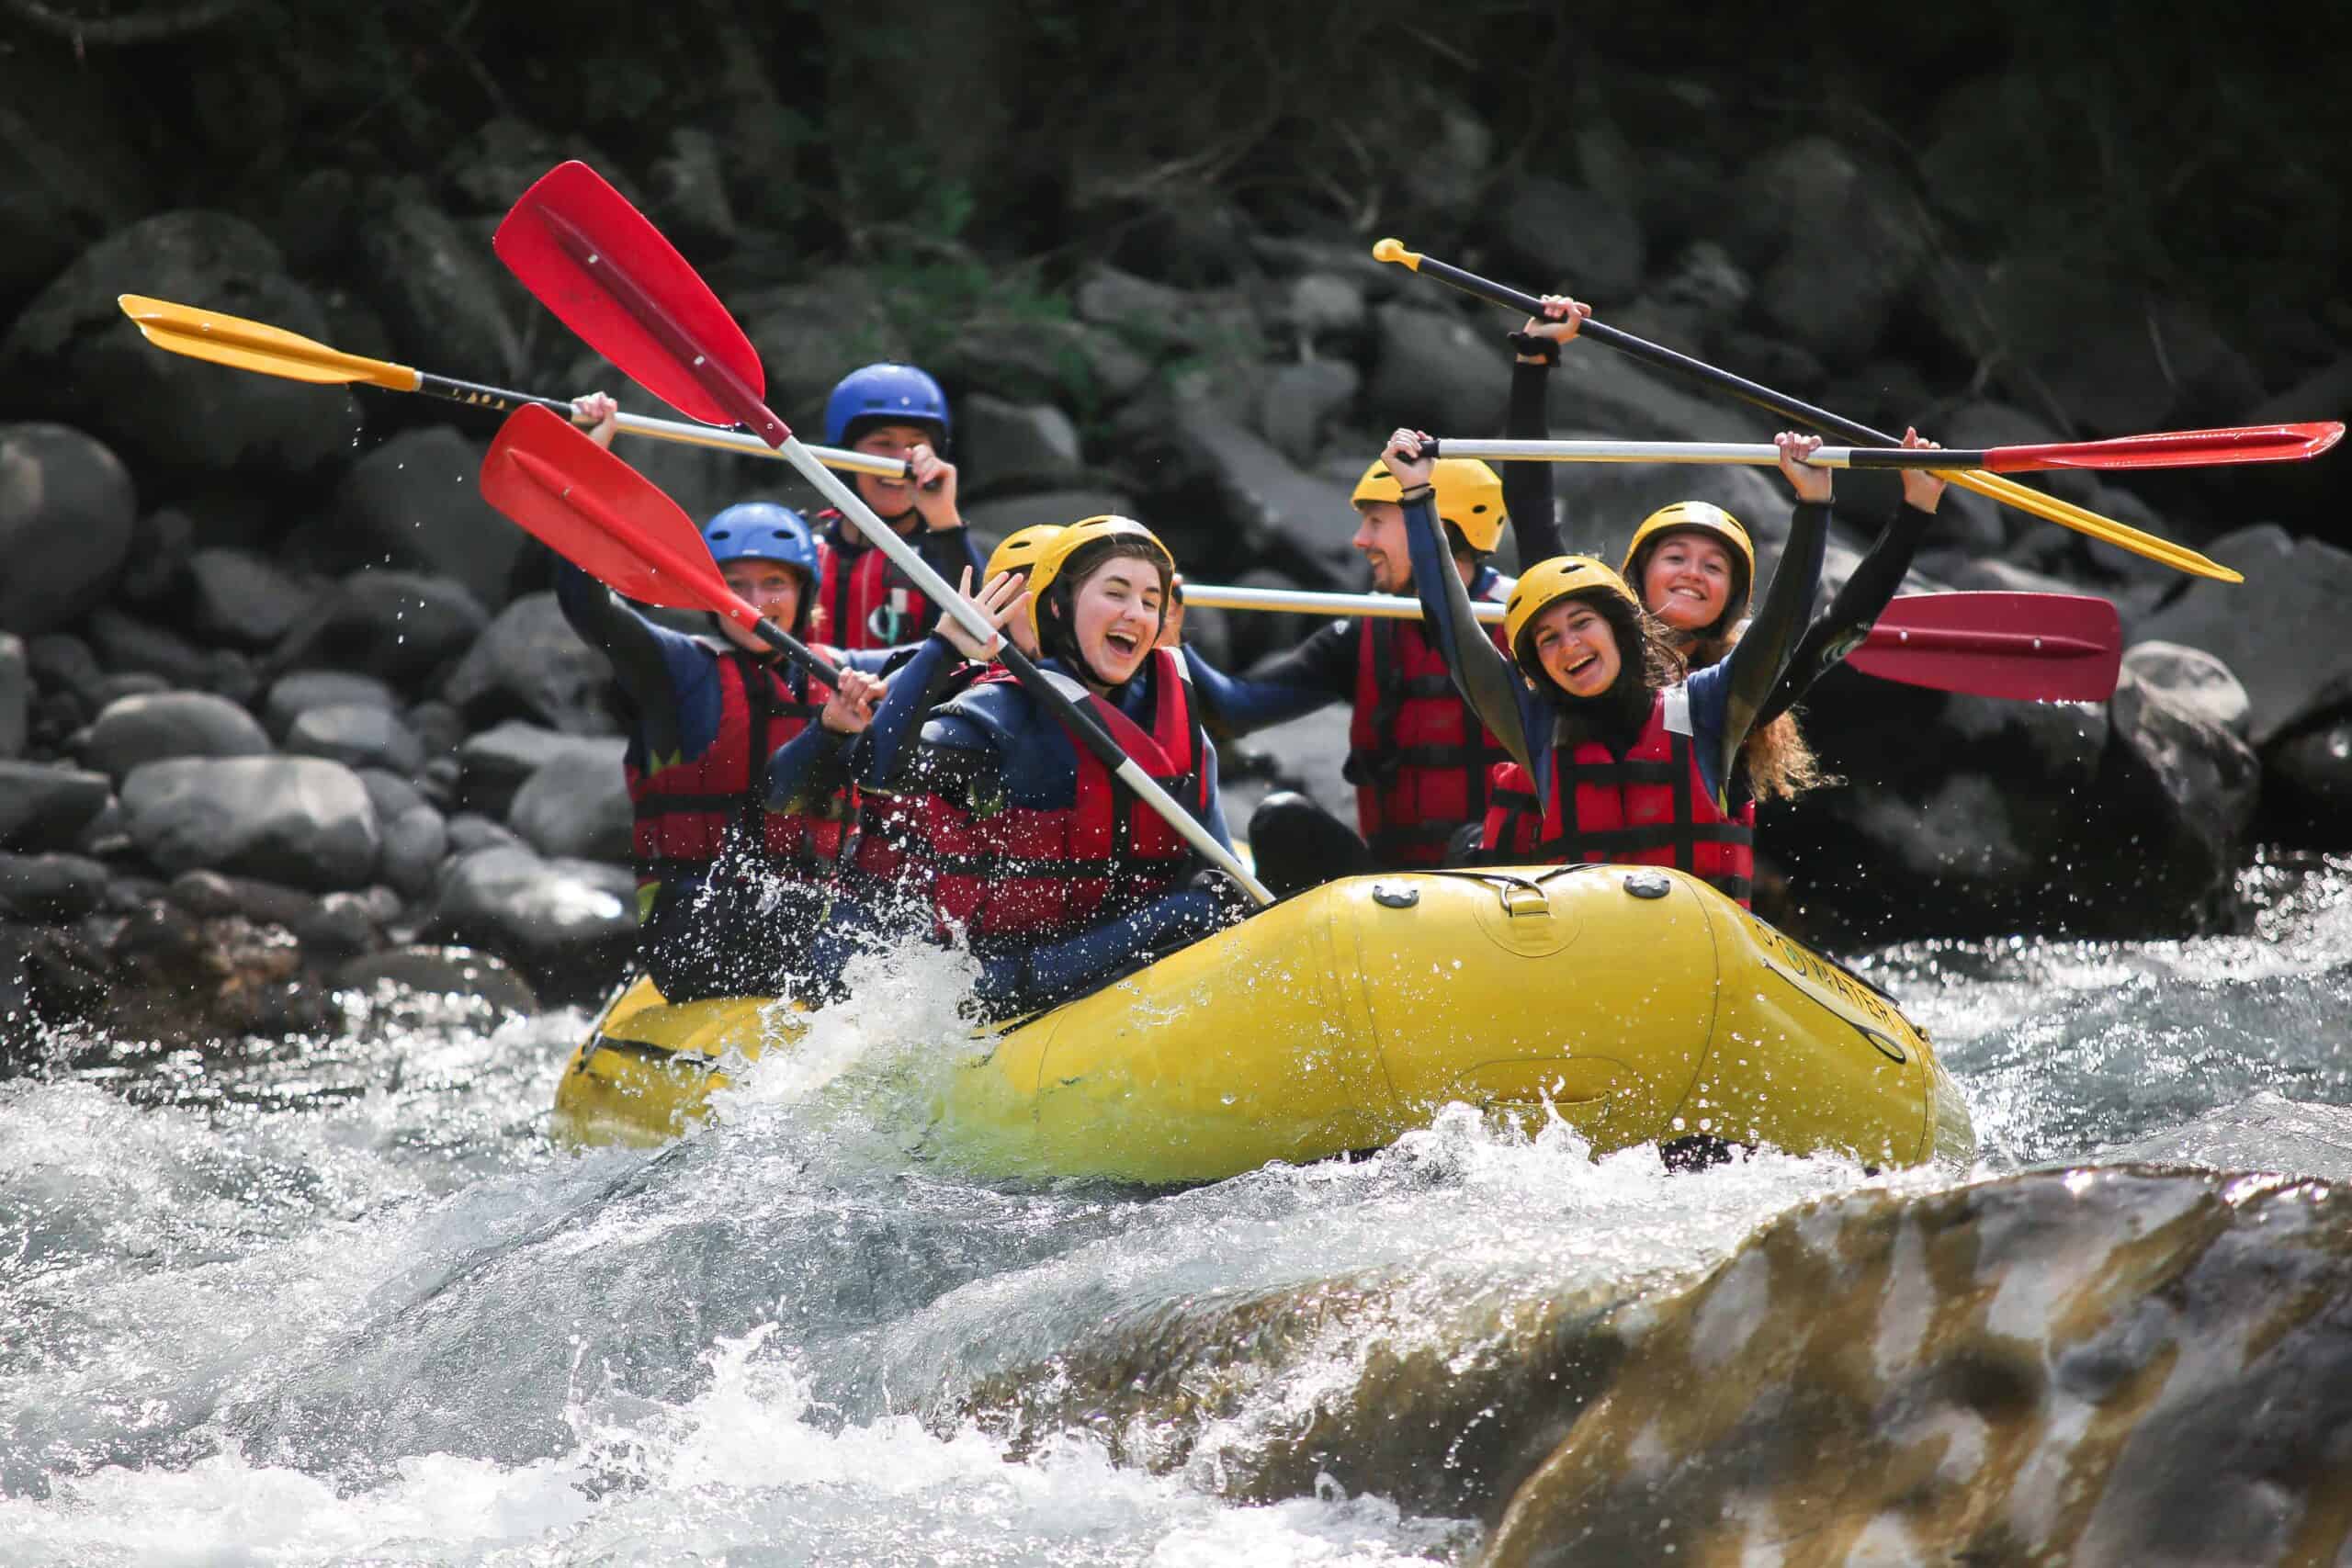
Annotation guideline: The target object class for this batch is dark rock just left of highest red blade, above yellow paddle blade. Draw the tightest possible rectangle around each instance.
[360,181,522,386]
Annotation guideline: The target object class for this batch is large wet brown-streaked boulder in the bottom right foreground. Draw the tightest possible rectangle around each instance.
[1482,1168,2352,1568]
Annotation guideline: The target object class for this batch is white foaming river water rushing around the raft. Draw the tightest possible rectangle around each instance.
[0,858,2352,1565]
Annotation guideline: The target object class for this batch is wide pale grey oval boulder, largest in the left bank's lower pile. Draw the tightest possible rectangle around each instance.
[122,757,381,888]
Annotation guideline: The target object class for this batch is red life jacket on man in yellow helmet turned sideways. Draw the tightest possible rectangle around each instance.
[1340,594,1508,870]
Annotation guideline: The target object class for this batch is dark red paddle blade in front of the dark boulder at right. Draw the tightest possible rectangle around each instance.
[1847,592,2124,703]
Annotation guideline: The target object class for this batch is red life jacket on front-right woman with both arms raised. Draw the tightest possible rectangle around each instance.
[1482,686,1755,908]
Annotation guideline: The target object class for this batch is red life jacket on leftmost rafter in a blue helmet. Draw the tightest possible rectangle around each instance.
[626,647,854,917]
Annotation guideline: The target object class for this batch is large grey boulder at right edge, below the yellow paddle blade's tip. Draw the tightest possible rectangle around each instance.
[2138,525,2352,745]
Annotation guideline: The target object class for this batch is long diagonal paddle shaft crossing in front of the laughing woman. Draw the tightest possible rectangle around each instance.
[538,192,1275,905]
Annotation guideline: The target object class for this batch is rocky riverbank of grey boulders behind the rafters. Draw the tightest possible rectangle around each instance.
[0,12,2352,1051]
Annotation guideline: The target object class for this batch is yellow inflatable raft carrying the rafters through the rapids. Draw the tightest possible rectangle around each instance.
[555,865,1975,1182]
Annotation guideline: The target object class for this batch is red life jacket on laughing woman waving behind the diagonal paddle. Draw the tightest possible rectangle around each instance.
[908,649,1209,942]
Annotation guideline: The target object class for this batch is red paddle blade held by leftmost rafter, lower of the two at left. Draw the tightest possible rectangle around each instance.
[482,404,738,626]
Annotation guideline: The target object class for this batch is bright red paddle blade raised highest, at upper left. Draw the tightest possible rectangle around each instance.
[492,160,790,442]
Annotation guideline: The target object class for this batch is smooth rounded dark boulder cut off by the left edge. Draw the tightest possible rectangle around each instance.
[0,421,139,637]
